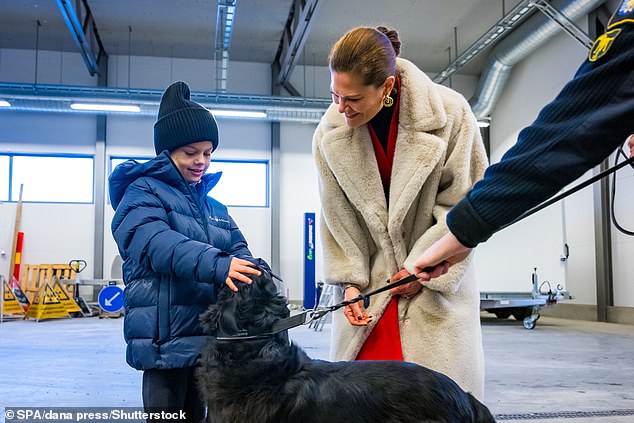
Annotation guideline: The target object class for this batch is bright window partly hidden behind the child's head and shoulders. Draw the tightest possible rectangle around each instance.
[110,157,269,207]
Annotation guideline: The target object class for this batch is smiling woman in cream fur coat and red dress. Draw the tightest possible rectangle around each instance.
[313,27,487,399]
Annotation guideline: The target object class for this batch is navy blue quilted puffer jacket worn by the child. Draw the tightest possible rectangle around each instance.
[109,151,268,370]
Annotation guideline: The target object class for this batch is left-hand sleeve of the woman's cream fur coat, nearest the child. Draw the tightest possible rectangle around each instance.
[313,125,373,289]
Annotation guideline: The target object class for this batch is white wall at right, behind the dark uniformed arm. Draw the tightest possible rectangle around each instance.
[476,16,634,307]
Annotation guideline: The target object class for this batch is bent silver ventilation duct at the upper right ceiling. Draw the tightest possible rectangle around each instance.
[469,0,605,119]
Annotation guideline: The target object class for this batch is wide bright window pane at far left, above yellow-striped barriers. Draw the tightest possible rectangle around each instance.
[10,155,94,203]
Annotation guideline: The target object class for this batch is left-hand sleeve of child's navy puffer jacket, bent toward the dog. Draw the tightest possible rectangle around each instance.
[112,180,232,284]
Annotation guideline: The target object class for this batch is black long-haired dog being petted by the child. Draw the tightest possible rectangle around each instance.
[198,272,495,423]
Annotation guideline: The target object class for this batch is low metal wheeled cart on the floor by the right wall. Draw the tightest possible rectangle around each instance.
[480,269,572,329]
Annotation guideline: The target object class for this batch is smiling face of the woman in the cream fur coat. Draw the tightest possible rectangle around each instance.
[330,71,394,128]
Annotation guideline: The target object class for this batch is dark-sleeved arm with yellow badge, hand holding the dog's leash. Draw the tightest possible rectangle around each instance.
[413,0,634,281]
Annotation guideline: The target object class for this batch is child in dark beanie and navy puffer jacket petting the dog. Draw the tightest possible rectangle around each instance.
[110,82,268,422]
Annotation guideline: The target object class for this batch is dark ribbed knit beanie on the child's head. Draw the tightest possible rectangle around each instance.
[154,81,218,154]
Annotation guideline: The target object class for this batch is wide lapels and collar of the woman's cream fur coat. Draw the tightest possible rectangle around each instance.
[322,59,447,262]
